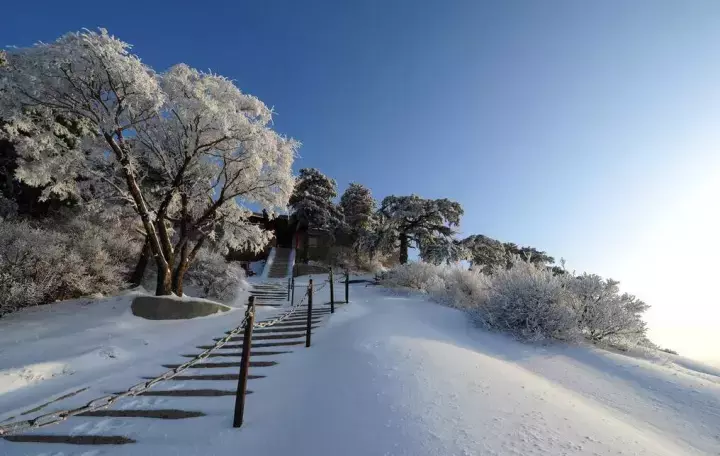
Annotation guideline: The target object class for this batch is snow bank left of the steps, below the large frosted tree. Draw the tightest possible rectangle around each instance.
[0,291,265,424]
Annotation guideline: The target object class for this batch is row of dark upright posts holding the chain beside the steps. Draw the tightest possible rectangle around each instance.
[233,269,350,428]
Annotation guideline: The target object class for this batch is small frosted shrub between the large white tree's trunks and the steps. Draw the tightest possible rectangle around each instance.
[185,248,247,301]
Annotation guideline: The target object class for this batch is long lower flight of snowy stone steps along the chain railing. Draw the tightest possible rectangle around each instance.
[0,282,329,448]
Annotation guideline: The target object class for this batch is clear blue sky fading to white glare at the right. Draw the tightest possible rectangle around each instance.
[0,0,720,360]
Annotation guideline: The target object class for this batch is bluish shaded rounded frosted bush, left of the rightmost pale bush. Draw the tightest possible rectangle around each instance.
[473,259,577,339]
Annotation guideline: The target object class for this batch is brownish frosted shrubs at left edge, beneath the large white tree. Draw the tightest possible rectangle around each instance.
[0,218,134,315]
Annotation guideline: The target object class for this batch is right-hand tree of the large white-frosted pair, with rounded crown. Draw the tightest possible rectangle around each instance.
[136,64,298,294]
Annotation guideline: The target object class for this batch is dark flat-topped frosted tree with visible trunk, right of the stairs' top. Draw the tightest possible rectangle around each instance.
[379,195,463,264]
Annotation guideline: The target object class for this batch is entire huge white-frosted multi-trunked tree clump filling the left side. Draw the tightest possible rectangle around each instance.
[0,30,298,294]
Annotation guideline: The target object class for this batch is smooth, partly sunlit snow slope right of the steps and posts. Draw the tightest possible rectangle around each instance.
[222,288,720,456]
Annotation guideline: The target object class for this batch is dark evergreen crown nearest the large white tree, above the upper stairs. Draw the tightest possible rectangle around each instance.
[290,168,342,232]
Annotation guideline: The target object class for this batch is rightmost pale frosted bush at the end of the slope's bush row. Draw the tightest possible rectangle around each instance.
[567,274,650,342]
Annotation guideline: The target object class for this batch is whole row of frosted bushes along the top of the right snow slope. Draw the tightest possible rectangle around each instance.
[382,257,649,348]
